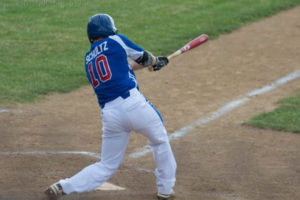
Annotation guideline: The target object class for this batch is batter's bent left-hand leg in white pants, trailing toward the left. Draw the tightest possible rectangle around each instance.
[55,103,130,194]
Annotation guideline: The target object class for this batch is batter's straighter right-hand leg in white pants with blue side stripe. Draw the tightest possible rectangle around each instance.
[129,96,177,194]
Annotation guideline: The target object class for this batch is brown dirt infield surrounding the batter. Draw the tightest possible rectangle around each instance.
[0,6,300,200]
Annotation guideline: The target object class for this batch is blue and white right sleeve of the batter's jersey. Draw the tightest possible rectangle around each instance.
[109,34,144,60]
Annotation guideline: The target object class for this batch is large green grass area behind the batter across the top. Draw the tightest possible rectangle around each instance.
[0,0,300,104]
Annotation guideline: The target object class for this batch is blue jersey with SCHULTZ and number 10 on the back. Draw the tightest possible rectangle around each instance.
[85,34,144,105]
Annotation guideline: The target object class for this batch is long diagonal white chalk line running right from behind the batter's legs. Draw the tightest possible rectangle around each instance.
[129,70,300,158]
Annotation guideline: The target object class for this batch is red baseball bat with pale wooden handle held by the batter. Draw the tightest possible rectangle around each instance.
[149,34,208,71]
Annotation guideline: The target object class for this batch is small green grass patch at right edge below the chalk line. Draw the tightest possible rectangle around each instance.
[248,93,300,133]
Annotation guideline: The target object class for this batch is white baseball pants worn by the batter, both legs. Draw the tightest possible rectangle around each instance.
[59,88,177,194]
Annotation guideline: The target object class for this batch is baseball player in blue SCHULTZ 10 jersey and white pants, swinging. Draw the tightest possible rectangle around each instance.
[46,14,176,199]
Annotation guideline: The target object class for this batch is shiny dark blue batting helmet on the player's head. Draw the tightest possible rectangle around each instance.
[87,14,118,43]
